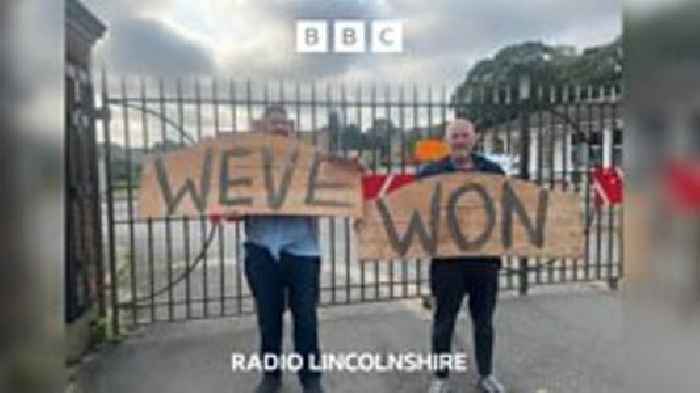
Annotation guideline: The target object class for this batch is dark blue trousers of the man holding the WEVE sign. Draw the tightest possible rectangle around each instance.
[245,242,321,385]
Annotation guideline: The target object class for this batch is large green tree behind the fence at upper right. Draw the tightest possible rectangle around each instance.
[452,37,622,128]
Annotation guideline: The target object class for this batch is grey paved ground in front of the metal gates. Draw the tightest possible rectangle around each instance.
[78,287,624,393]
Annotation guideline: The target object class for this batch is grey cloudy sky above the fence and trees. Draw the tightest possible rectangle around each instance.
[83,0,622,86]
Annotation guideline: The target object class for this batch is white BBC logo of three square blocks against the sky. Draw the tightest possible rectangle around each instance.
[296,19,403,53]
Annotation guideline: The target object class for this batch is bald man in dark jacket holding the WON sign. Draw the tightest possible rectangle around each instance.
[417,119,505,393]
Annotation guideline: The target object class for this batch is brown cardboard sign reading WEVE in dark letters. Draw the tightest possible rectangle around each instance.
[138,132,362,217]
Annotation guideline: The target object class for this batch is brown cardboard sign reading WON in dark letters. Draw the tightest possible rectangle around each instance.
[356,174,584,260]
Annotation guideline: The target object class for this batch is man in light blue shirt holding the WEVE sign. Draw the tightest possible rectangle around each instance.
[227,105,323,393]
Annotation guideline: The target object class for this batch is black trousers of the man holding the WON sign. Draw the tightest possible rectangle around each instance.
[430,259,500,378]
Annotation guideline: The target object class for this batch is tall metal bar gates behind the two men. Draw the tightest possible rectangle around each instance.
[98,73,623,332]
